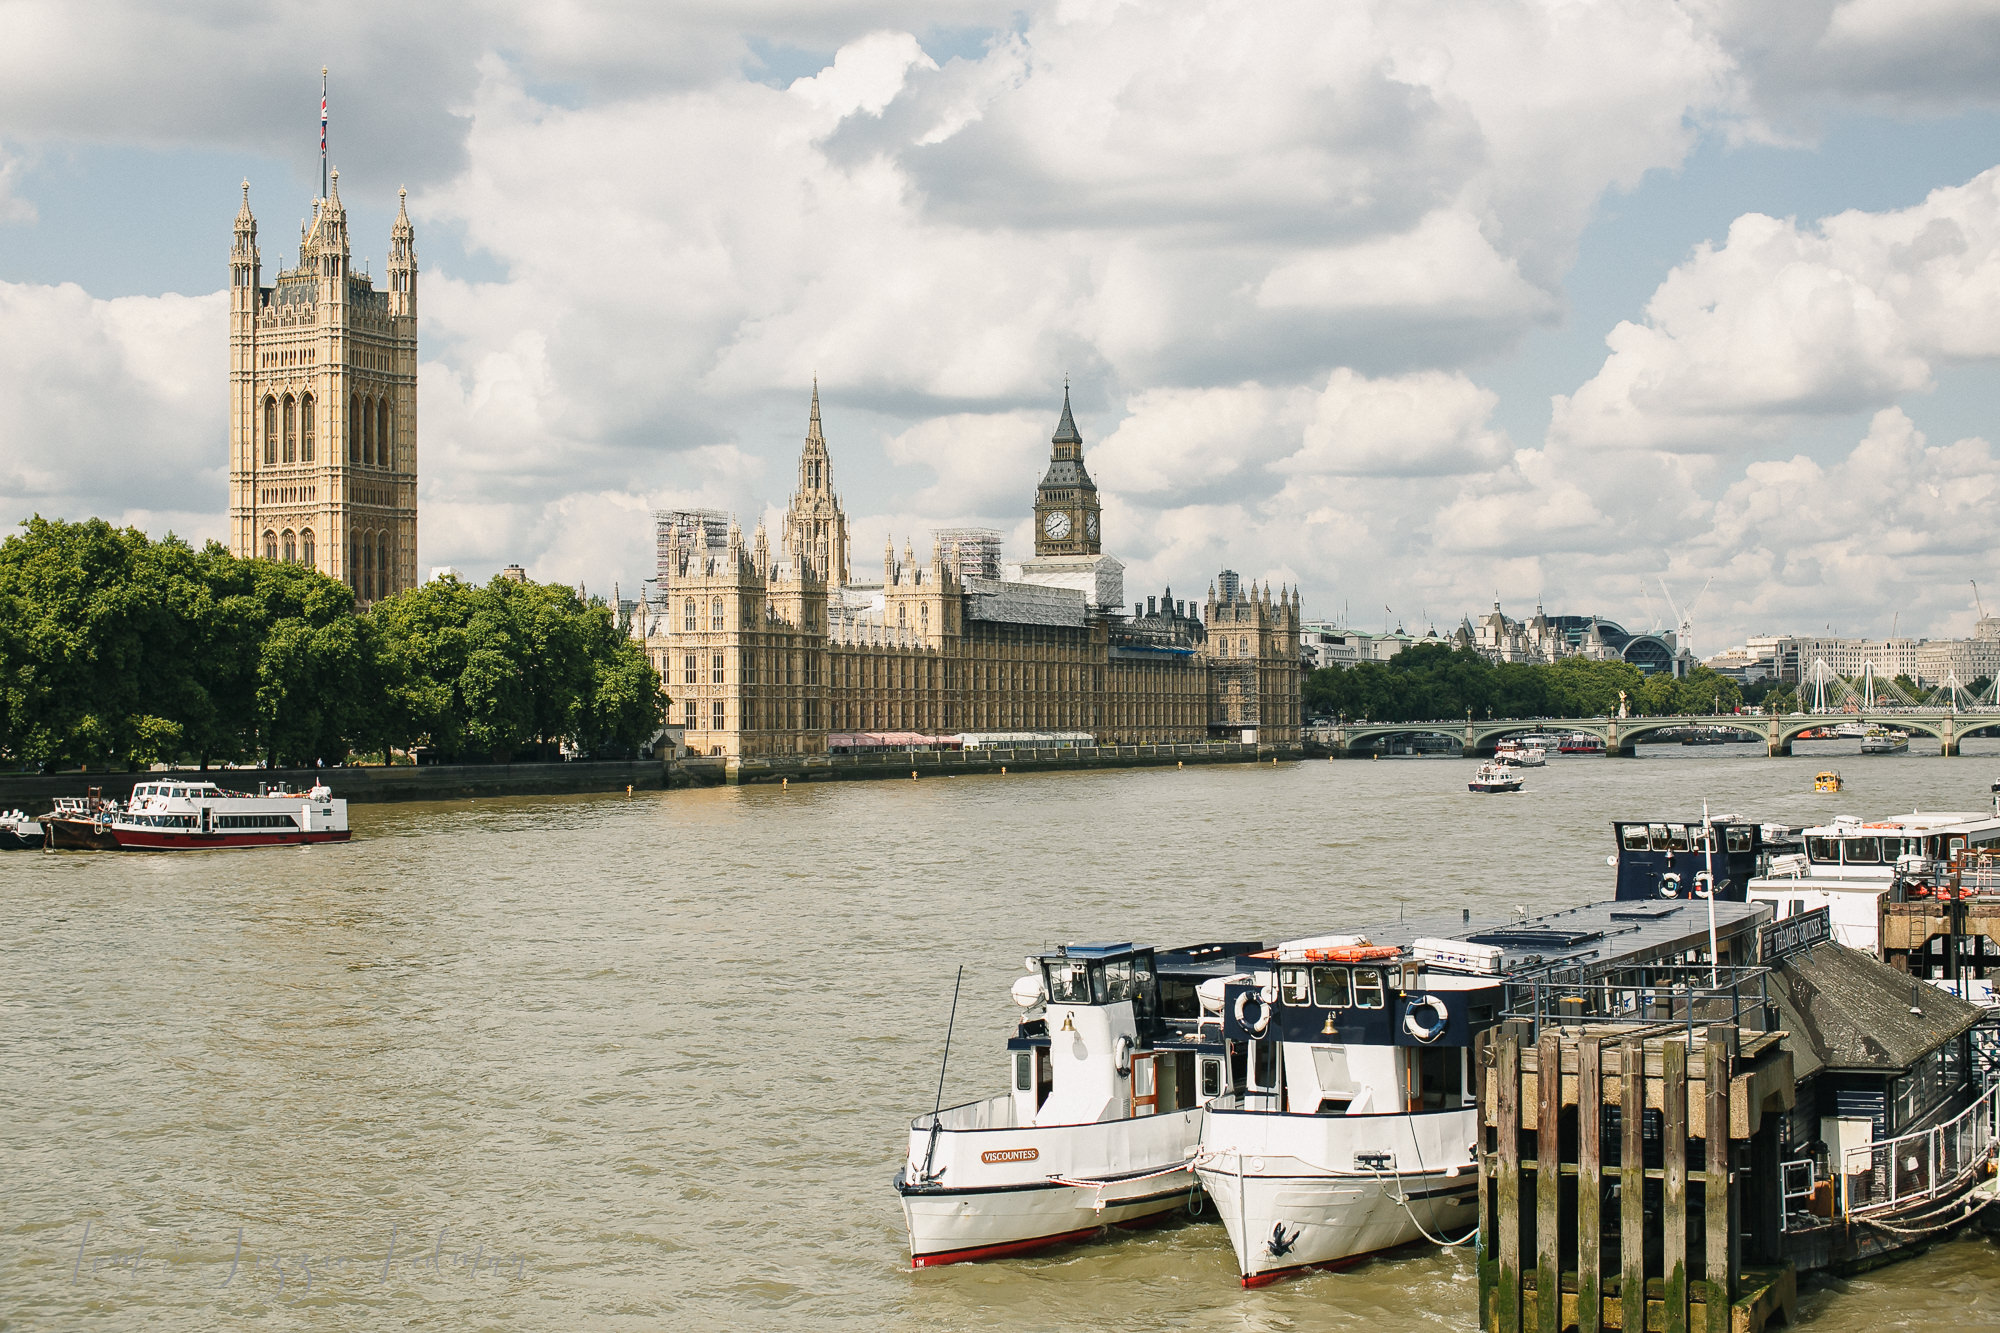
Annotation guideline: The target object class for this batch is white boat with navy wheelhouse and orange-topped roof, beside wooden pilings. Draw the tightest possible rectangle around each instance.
[1196,901,1768,1287]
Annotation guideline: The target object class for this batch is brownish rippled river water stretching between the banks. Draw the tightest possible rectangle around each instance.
[0,743,2000,1333]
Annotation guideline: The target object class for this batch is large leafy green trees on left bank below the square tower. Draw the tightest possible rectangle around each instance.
[0,516,666,769]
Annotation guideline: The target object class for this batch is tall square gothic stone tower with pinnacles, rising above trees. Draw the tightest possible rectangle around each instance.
[230,172,416,604]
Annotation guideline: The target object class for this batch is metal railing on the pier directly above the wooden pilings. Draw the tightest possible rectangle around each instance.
[1500,963,1772,1041]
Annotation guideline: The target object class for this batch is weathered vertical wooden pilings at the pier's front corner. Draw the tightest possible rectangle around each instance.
[1476,1019,1792,1333]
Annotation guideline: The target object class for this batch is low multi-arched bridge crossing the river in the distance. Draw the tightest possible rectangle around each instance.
[1304,709,2000,759]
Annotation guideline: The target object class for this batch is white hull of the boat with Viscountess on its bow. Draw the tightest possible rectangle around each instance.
[896,1097,1202,1269]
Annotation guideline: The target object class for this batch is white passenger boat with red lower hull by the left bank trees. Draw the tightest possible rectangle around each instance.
[110,781,350,851]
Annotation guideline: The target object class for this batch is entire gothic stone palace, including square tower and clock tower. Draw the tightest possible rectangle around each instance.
[230,163,1302,759]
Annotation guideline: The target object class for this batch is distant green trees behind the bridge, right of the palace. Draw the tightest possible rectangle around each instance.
[1304,642,1742,723]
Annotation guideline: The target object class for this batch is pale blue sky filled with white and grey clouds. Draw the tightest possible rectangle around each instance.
[0,0,2000,656]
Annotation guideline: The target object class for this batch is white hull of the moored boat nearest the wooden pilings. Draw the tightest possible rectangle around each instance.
[1198,1109,1478,1287]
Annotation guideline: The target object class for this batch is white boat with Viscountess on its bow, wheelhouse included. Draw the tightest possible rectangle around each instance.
[896,943,1262,1267]
